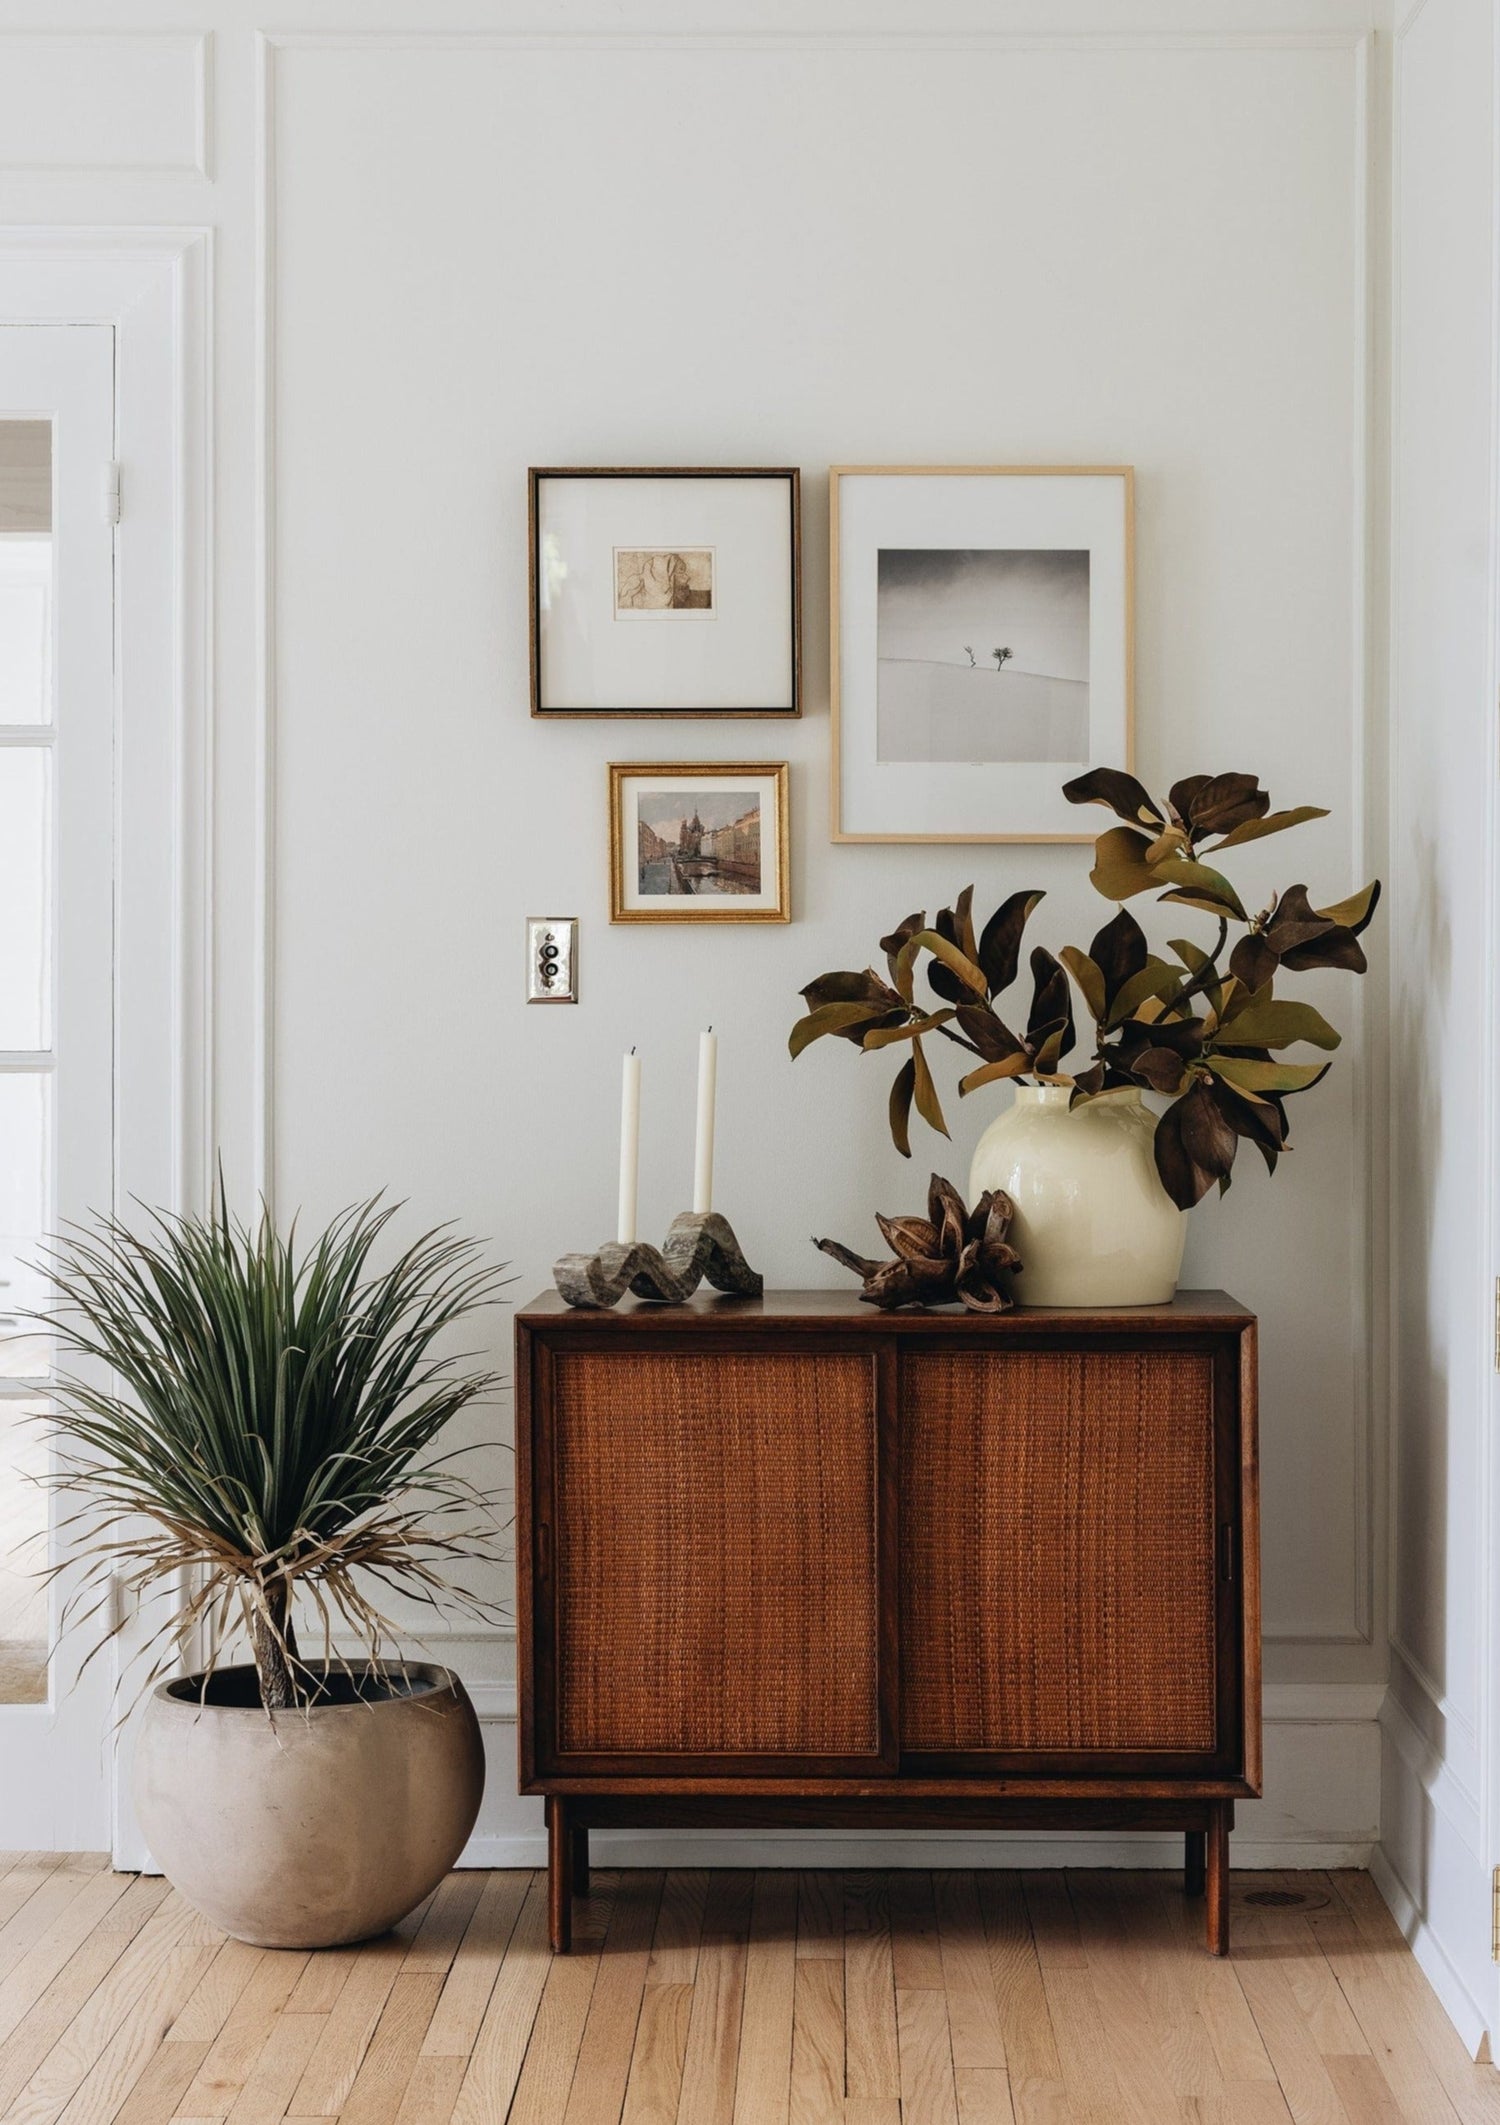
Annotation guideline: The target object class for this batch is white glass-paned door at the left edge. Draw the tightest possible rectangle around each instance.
[0,325,115,1849]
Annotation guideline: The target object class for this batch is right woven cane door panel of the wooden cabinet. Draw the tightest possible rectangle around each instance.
[901,1349,1215,1751]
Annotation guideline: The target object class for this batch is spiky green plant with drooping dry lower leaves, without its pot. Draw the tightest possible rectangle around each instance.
[45,1177,504,1711]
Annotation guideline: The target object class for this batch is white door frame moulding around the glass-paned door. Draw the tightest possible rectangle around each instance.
[0,227,215,1866]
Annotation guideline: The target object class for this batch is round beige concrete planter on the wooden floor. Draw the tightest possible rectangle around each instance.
[136,1664,484,1949]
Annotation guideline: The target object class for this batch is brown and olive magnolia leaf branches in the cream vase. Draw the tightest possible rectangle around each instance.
[790,767,1381,1209]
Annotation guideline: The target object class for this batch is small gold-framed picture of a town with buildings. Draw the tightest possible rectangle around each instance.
[610,761,792,922]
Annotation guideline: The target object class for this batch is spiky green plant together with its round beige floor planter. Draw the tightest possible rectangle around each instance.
[47,1179,499,1949]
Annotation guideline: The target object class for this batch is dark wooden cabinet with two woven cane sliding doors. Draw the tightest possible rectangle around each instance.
[516,1292,1260,1953]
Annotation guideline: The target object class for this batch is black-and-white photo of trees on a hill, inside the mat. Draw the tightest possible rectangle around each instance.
[875,546,1088,767]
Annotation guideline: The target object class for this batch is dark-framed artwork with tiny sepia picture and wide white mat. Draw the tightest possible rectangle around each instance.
[529,465,801,716]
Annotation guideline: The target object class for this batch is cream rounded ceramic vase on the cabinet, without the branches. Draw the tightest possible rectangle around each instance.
[969,1084,1188,1307]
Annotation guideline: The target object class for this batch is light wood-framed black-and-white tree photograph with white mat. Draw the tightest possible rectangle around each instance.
[829,465,1135,842]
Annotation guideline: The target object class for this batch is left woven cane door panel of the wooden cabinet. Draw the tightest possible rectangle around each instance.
[555,1352,880,1755]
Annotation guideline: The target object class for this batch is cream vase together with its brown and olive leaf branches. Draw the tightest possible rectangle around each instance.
[790,767,1379,1305]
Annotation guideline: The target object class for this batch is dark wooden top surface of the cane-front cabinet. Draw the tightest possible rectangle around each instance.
[516,1290,1256,1337]
